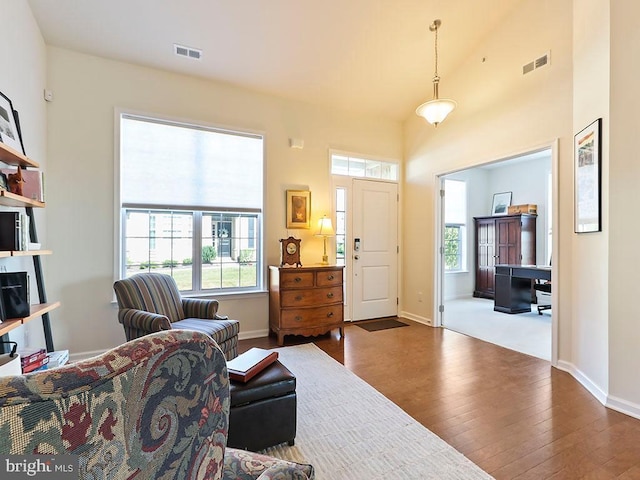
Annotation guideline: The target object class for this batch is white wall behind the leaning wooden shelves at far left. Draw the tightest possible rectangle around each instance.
[0,0,52,348]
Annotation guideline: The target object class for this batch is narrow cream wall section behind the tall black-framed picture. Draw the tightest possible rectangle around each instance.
[560,0,608,401]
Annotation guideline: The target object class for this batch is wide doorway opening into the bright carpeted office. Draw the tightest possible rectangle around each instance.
[435,143,557,362]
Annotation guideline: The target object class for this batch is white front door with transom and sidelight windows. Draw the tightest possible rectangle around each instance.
[330,151,399,321]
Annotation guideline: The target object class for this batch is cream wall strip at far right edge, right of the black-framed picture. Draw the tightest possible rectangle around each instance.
[608,1,640,417]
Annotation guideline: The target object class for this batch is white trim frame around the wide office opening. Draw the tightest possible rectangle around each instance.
[433,138,560,366]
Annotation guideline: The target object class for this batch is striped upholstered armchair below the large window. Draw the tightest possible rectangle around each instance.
[113,273,240,360]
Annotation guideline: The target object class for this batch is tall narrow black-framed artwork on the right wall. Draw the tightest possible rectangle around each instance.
[573,118,602,233]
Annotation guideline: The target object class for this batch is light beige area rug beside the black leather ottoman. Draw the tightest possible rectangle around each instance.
[264,344,492,480]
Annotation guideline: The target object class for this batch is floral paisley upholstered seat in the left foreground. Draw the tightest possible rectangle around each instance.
[0,330,314,480]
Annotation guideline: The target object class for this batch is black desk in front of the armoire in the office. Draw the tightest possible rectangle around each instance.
[493,265,551,313]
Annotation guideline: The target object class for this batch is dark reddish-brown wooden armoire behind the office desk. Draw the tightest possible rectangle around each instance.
[473,214,536,298]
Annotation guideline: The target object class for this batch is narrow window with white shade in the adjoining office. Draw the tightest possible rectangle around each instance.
[444,180,467,272]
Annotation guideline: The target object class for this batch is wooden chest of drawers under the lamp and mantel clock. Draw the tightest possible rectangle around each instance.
[269,265,344,345]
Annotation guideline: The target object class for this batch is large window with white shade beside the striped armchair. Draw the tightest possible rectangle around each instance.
[119,114,264,293]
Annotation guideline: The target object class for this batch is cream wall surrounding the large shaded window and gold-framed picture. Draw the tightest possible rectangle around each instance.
[47,47,402,353]
